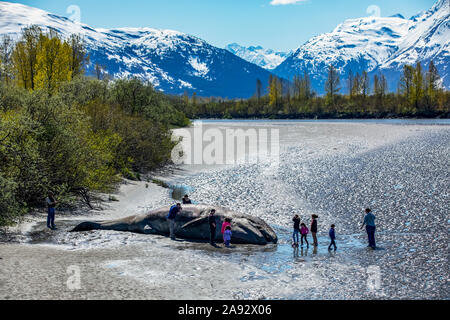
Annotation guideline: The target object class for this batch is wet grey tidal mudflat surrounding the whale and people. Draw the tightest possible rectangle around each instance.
[0,121,450,299]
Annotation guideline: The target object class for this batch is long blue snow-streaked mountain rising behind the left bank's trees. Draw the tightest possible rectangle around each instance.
[0,2,270,98]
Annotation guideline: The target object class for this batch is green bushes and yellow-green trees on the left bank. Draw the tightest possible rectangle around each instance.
[0,26,190,226]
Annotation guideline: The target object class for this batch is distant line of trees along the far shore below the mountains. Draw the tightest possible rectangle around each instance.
[177,62,450,119]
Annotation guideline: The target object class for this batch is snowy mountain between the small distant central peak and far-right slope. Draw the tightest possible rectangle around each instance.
[274,17,410,93]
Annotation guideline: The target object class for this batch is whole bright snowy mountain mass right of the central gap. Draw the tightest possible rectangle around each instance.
[274,0,450,93]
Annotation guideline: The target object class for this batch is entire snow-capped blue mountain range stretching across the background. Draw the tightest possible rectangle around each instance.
[0,0,450,98]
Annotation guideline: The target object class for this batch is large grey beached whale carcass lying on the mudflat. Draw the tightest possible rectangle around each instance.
[72,205,278,245]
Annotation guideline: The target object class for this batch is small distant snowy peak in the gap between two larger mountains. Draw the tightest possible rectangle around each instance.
[225,43,292,70]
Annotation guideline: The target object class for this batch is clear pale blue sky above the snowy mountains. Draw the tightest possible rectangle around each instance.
[5,0,435,51]
